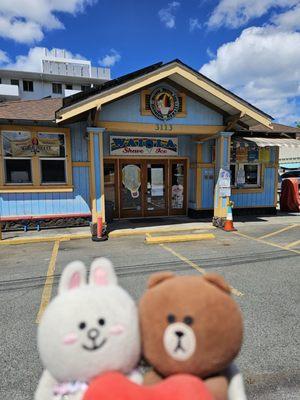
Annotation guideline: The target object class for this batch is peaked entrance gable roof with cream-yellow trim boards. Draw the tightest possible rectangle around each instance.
[56,59,272,126]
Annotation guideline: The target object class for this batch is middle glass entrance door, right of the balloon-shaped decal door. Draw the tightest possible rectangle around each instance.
[144,160,168,216]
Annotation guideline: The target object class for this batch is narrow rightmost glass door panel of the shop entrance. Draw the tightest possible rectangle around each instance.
[169,160,187,215]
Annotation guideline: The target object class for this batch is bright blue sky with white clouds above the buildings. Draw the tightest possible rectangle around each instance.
[0,0,300,125]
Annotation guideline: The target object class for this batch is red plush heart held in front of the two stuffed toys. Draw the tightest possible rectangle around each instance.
[83,372,214,400]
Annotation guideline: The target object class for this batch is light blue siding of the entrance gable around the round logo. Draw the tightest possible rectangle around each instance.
[99,85,223,125]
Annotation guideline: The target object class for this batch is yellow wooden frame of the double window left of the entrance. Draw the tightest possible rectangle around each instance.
[0,125,73,193]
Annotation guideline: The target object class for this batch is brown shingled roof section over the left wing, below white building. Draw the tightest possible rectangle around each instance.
[0,98,62,122]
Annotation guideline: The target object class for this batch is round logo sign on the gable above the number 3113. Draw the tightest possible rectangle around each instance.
[150,88,179,121]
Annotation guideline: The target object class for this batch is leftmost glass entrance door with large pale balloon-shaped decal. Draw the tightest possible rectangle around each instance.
[119,160,144,218]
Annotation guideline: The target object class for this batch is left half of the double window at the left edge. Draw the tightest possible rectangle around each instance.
[2,132,32,184]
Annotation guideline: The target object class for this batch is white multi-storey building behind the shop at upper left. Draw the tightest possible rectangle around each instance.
[0,49,110,101]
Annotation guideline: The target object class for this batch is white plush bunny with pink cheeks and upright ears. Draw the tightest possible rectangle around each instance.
[35,258,140,400]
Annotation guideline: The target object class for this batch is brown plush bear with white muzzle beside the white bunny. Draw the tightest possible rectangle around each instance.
[139,272,243,400]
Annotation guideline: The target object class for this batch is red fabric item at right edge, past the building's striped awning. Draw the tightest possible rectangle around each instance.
[280,178,300,212]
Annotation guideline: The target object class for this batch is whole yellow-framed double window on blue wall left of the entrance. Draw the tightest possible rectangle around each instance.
[0,127,72,190]
